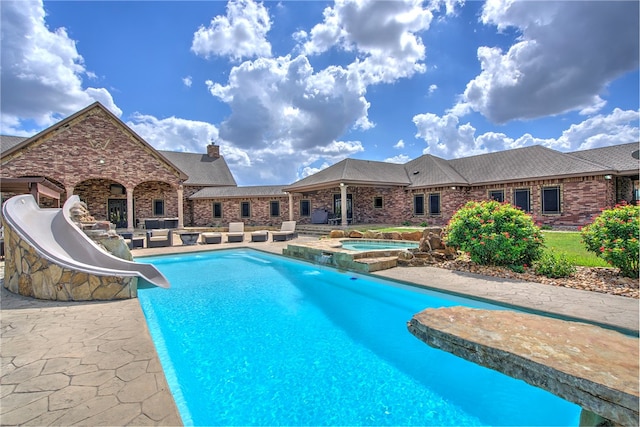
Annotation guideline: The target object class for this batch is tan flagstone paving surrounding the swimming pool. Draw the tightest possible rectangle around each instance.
[0,236,639,426]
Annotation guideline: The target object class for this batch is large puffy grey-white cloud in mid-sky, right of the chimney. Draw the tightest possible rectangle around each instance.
[207,56,372,151]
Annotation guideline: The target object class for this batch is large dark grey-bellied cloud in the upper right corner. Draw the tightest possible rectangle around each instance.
[451,0,640,123]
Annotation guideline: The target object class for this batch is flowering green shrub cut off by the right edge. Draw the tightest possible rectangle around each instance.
[581,203,640,278]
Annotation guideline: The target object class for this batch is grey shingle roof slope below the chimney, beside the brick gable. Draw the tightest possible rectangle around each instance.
[159,151,237,186]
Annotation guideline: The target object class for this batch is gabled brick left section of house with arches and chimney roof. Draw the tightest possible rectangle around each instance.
[0,103,236,229]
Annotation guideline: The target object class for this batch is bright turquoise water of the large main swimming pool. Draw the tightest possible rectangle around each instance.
[138,249,580,426]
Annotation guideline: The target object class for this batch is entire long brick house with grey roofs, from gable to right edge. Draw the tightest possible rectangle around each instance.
[0,103,639,229]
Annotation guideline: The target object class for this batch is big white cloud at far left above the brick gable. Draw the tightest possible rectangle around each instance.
[0,1,122,134]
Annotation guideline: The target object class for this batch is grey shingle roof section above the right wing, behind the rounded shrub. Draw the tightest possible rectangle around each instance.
[449,145,608,185]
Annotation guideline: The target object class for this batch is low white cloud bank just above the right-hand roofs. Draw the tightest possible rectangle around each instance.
[413,108,640,159]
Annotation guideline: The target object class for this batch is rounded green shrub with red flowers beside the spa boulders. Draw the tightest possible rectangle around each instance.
[445,200,543,268]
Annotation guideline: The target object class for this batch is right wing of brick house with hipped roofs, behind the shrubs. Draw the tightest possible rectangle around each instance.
[283,143,638,227]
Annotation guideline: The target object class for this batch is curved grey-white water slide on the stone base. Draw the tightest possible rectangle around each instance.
[2,194,169,288]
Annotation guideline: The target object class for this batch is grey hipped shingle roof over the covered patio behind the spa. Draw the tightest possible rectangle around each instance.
[285,159,411,191]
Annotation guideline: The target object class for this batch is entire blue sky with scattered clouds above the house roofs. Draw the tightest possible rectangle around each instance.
[0,0,640,185]
